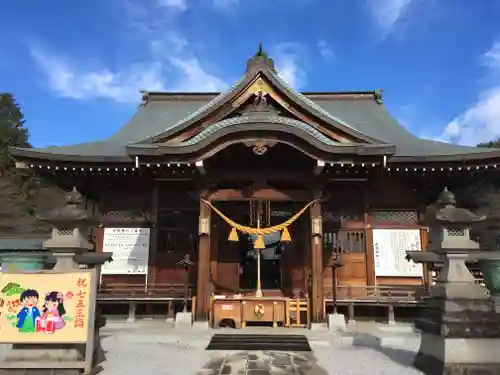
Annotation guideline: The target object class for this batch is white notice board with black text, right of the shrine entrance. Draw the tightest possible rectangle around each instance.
[373,229,424,277]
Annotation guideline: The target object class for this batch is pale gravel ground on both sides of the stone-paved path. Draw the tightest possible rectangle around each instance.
[95,329,422,375]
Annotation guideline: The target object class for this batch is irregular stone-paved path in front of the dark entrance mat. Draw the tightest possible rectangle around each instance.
[198,351,328,375]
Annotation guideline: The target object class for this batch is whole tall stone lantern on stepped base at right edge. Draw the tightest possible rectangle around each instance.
[407,188,500,375]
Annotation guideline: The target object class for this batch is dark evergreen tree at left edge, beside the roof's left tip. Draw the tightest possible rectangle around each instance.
[0,92,30,173]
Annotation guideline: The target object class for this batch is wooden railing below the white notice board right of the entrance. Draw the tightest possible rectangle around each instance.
[325,285,427,304]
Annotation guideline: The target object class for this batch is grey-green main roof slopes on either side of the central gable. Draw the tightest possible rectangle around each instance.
[9,94,494,159]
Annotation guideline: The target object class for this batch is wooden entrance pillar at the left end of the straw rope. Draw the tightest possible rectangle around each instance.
[195,195,211,321]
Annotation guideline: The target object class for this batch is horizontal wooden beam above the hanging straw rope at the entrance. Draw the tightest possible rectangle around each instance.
[208,188,310,202]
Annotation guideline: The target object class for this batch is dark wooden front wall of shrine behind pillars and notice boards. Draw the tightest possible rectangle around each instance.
[95,180,426,295]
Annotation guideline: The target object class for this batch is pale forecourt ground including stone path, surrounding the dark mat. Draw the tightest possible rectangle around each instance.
[0,321,421,375]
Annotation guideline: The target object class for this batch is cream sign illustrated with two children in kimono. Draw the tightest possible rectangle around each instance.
[0,272,94,343]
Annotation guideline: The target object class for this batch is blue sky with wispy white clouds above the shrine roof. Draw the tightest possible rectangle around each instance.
[0,0,500,147]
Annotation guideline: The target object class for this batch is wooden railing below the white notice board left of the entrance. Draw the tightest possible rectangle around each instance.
[98,283,194,300]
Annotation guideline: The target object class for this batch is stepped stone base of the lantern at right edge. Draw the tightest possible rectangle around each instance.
[414,298,500,375]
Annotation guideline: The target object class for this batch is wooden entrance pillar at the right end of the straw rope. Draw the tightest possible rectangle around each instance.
[310,202,325,323]
